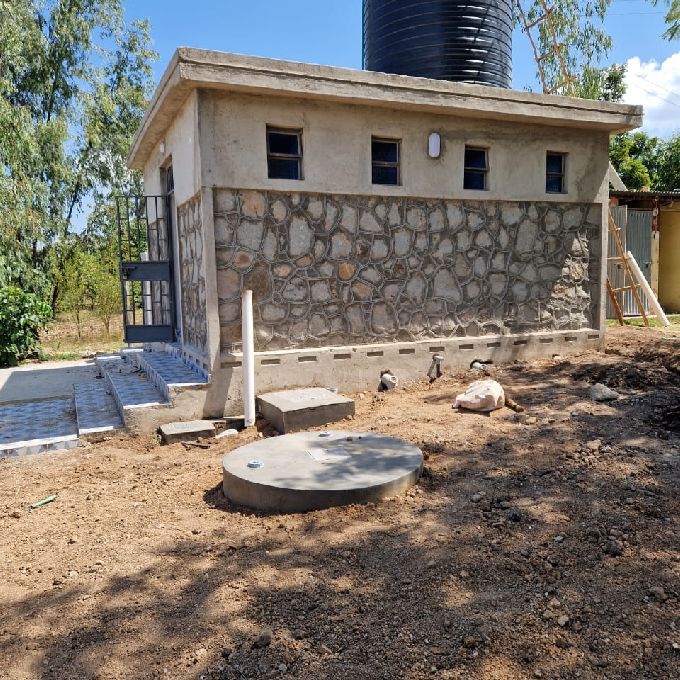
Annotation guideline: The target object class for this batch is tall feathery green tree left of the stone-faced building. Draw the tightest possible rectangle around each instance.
[0,0,155,306]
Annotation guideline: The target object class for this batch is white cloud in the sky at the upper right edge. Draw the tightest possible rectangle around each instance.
[624,52,680,137]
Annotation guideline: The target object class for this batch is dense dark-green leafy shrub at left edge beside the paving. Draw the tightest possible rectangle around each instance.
[0,287,52,366]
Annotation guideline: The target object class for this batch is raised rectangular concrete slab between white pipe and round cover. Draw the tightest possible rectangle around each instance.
[257,387,354,434]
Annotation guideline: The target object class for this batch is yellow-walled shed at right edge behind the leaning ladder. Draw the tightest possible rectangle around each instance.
[611,191,680,316]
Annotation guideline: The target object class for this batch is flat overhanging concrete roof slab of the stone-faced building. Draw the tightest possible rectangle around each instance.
[128,47,642,169]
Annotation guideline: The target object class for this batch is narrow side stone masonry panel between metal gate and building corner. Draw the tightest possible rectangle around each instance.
[177,194,208,355]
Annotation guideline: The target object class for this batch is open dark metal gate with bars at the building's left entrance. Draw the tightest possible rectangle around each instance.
[116,196,175,343]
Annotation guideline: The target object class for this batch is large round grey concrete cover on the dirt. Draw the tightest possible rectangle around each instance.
[222,431,423,512]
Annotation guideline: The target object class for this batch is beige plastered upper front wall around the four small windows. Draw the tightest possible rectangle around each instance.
[199,91,609,203]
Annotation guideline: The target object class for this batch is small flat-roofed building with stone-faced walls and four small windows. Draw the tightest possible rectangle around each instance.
[122,48,642,414]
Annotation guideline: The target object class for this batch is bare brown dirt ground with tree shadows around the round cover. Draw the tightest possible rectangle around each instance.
[0,329,680,680]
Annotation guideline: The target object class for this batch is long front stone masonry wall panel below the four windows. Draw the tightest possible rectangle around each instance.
[214,189,602,350]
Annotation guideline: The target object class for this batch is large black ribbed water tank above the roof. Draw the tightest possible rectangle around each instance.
[364,0,513,87]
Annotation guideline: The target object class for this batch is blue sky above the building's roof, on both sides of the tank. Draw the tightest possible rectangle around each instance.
[127,0,680,135]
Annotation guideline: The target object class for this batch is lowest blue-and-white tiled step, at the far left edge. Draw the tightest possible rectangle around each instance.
[0,398,78,458]
